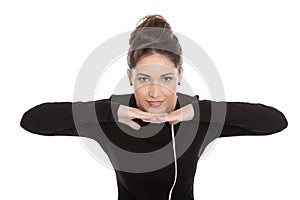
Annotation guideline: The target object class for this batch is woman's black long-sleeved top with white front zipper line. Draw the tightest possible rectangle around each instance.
[20,93,288,200]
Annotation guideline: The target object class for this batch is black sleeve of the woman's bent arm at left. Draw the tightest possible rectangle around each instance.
[20,99,119,137]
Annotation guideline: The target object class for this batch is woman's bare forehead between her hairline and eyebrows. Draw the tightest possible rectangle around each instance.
[133,54,177,75]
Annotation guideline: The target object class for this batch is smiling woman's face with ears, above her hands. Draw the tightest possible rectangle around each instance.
[127,54,183,113]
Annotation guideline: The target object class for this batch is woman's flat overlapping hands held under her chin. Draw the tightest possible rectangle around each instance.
[118,104,194,130]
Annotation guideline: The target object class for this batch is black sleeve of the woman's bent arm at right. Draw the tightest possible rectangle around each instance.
[199,100,288,137]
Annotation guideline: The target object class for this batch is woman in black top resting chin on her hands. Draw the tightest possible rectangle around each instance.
[20,15,288,200]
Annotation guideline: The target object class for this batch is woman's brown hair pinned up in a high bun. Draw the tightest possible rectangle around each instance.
[127,15,182,72]
